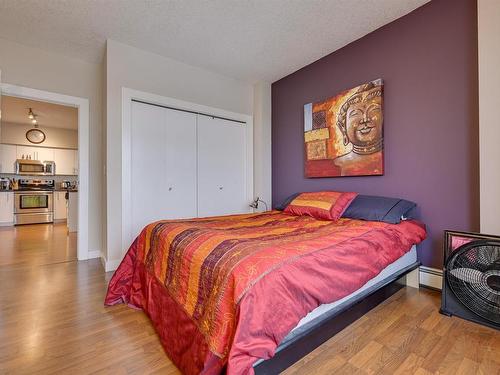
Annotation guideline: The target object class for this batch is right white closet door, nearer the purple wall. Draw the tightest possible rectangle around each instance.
[198,115,249,217]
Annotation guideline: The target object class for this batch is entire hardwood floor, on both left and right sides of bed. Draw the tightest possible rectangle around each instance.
[0,225,500,374]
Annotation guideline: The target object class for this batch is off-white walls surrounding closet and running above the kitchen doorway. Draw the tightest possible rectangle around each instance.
[0,39,271,268]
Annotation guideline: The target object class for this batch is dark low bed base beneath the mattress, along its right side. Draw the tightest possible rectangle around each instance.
[254,262,420,375]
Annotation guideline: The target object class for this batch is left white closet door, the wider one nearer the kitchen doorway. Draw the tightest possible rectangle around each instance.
[131,102,197,237]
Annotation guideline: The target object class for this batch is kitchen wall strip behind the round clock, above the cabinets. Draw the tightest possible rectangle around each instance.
[0,122,78,150]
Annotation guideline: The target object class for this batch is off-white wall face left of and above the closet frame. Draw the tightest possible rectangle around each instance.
[105,40,254,269]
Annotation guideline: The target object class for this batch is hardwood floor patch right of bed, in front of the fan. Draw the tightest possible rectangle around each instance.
[284,288,500,375]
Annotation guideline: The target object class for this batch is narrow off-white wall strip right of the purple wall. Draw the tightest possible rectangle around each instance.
[478,0,500,235]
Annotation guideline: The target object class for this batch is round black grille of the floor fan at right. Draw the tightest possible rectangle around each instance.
[446,241,500,324]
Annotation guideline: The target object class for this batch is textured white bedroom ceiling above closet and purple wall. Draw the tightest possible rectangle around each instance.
[0,0,429,82]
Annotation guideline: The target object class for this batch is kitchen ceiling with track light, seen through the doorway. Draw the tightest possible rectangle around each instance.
[2,95,78,130]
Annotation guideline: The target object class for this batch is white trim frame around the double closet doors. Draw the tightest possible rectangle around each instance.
[122,87,254,254]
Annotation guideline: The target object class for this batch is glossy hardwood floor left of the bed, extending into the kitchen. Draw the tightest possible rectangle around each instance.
[0,225,179,375]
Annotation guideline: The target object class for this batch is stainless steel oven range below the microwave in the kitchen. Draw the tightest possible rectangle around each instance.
[14,180,54,225]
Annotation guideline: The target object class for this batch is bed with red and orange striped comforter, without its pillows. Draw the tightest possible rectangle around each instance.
[105,211,425,374]
